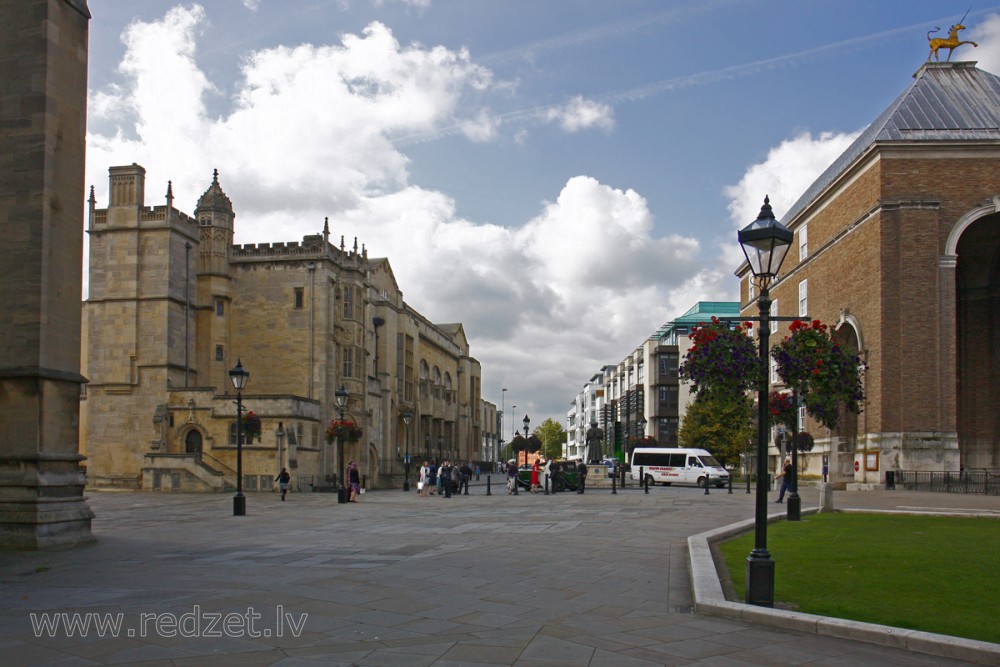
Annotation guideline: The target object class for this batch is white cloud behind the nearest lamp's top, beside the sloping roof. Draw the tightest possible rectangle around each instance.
[724,131,860,228]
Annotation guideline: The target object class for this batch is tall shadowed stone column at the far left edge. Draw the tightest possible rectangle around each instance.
[0,0,93,549]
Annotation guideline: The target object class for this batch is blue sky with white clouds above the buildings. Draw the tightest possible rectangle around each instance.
[84,0,1000,427]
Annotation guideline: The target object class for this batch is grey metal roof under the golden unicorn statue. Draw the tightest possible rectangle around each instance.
[784,62,1000,225]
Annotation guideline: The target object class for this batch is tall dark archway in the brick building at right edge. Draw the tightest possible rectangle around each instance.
[955,213,1000,469]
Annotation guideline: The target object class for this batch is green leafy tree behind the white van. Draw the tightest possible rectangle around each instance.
[677,392,755,468]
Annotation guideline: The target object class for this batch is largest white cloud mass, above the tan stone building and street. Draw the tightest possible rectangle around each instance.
[87,6,731,414]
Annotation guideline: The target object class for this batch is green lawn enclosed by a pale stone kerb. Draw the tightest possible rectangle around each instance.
[719,513,1000,643]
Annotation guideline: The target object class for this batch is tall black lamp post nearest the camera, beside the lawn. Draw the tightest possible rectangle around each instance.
[738,197,793,607]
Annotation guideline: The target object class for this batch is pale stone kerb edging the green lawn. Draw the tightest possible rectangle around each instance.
[688,508,1000,665]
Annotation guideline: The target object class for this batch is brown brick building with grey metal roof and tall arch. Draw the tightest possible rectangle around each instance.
[737,62,1000,484]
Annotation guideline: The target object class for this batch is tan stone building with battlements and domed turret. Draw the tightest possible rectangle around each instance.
[81,164,483,491]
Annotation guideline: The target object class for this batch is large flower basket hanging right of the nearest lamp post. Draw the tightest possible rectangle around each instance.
[771,320,865,429]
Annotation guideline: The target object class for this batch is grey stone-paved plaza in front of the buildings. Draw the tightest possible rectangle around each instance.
[0,484,1000,667]
